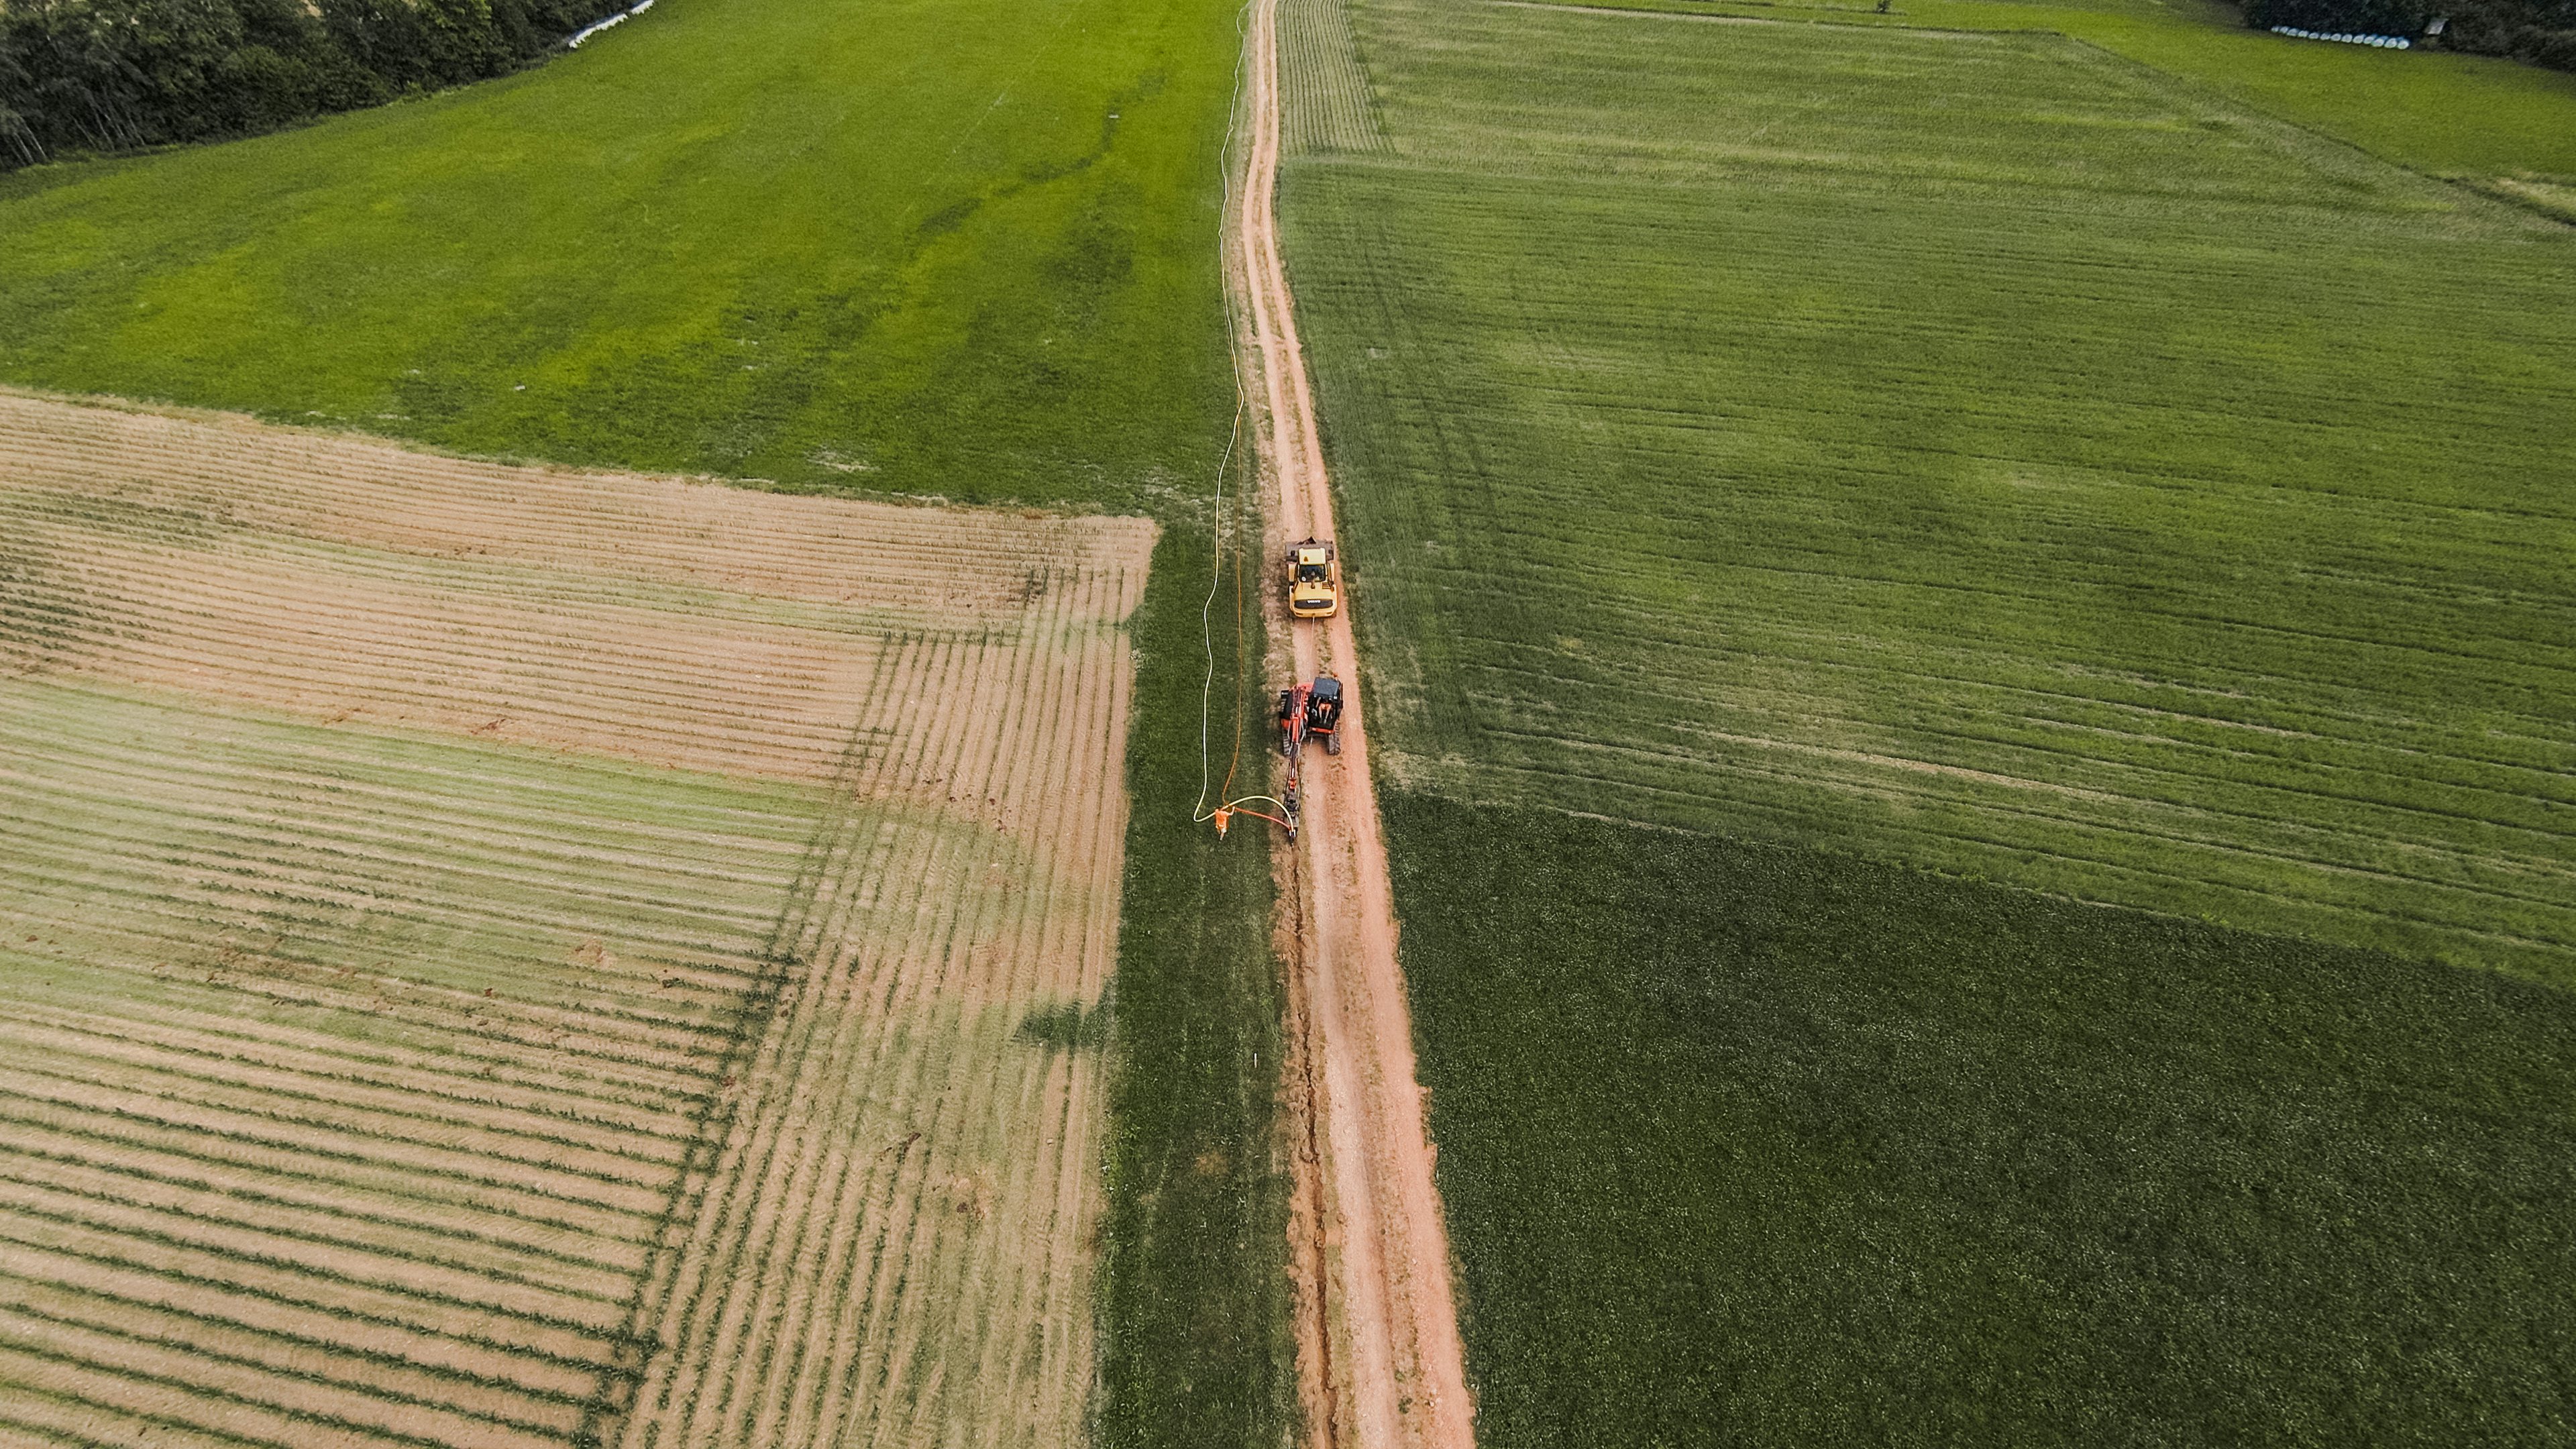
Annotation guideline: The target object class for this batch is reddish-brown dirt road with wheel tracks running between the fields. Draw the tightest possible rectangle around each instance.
[1234,0,1473,1449]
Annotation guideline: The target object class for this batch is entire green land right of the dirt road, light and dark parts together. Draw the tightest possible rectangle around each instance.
[1280,0,2576,1449]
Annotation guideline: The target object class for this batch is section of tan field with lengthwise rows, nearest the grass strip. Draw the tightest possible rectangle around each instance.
[626,559,1134,1449]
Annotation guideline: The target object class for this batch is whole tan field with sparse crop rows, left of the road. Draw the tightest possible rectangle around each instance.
[0,394,1154,1449]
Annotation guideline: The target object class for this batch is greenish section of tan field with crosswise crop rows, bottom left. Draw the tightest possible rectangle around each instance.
[0,678,773,1444]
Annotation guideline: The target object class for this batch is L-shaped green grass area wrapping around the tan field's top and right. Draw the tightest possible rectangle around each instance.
[0,0,1291,1423]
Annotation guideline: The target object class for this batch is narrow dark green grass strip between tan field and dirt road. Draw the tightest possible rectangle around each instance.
[1100,502,1296,1449]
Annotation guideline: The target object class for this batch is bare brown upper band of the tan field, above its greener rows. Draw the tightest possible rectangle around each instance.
[0,392,1151,779]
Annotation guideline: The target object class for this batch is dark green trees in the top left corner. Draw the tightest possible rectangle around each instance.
[0,0,631,170]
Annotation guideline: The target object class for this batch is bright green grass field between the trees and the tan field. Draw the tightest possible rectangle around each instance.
[0,0,1234,500]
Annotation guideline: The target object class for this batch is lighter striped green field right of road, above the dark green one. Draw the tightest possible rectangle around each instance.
[1283,0,2576,979]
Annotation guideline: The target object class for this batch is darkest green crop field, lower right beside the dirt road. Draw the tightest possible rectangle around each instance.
[1386,792,2576,1449]
